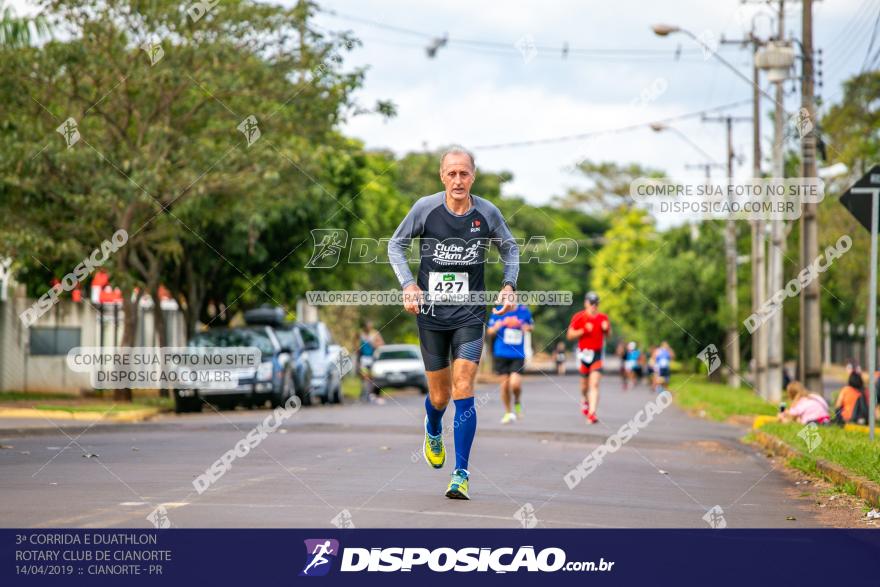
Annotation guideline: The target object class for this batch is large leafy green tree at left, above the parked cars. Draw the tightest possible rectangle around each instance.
[0,0,374,341]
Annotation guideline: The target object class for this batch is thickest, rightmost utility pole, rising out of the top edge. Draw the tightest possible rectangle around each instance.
[798,0,820,393]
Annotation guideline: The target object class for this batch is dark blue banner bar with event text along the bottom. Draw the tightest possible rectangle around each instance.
[0,529,880,587]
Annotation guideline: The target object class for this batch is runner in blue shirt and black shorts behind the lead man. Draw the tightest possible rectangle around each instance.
[488,305,534,424]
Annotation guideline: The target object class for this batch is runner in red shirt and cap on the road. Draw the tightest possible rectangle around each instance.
[566,291,611,424]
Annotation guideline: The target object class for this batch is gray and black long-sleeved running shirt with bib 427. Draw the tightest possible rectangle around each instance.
[388,192,519,330]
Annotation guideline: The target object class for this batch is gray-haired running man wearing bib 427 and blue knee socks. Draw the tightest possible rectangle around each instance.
[388,148,519,499]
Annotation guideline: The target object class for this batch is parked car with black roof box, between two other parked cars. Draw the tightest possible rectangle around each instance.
[244,306,318,406]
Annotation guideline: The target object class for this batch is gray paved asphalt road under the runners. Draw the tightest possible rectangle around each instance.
[0,375,819,528]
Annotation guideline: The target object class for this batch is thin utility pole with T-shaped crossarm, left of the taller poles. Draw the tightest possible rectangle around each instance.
[702,116,751,387]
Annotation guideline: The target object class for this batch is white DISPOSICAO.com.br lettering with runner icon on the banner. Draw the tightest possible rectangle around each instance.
[300,538,614,577]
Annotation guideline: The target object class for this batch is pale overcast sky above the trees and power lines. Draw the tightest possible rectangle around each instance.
[11,0,880,203]
